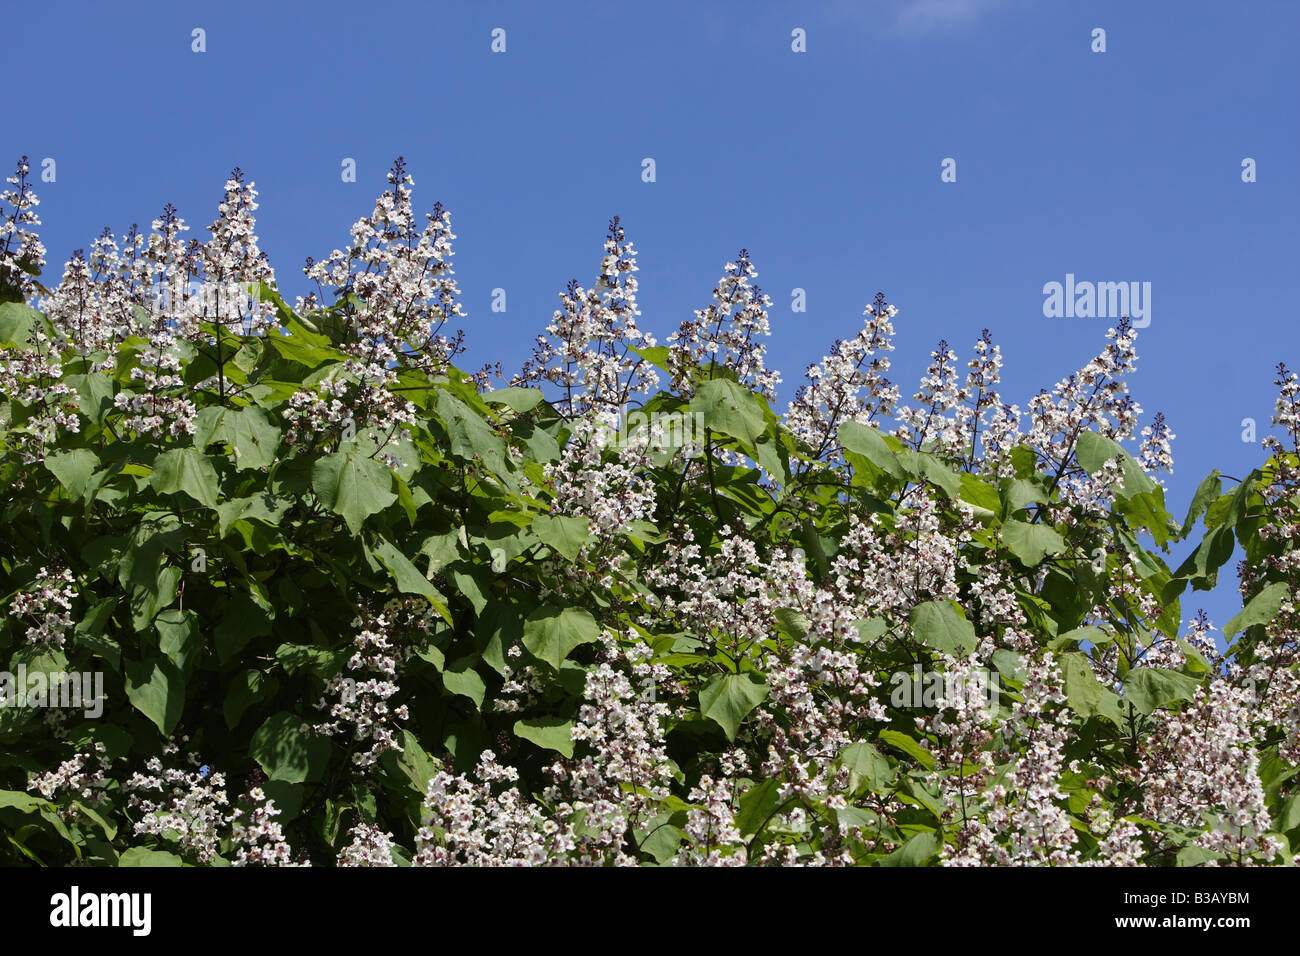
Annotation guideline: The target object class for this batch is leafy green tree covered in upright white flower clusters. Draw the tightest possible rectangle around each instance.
[0,160,1300,866]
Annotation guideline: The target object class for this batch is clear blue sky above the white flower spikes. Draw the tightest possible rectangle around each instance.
[0,0,1300,639]
